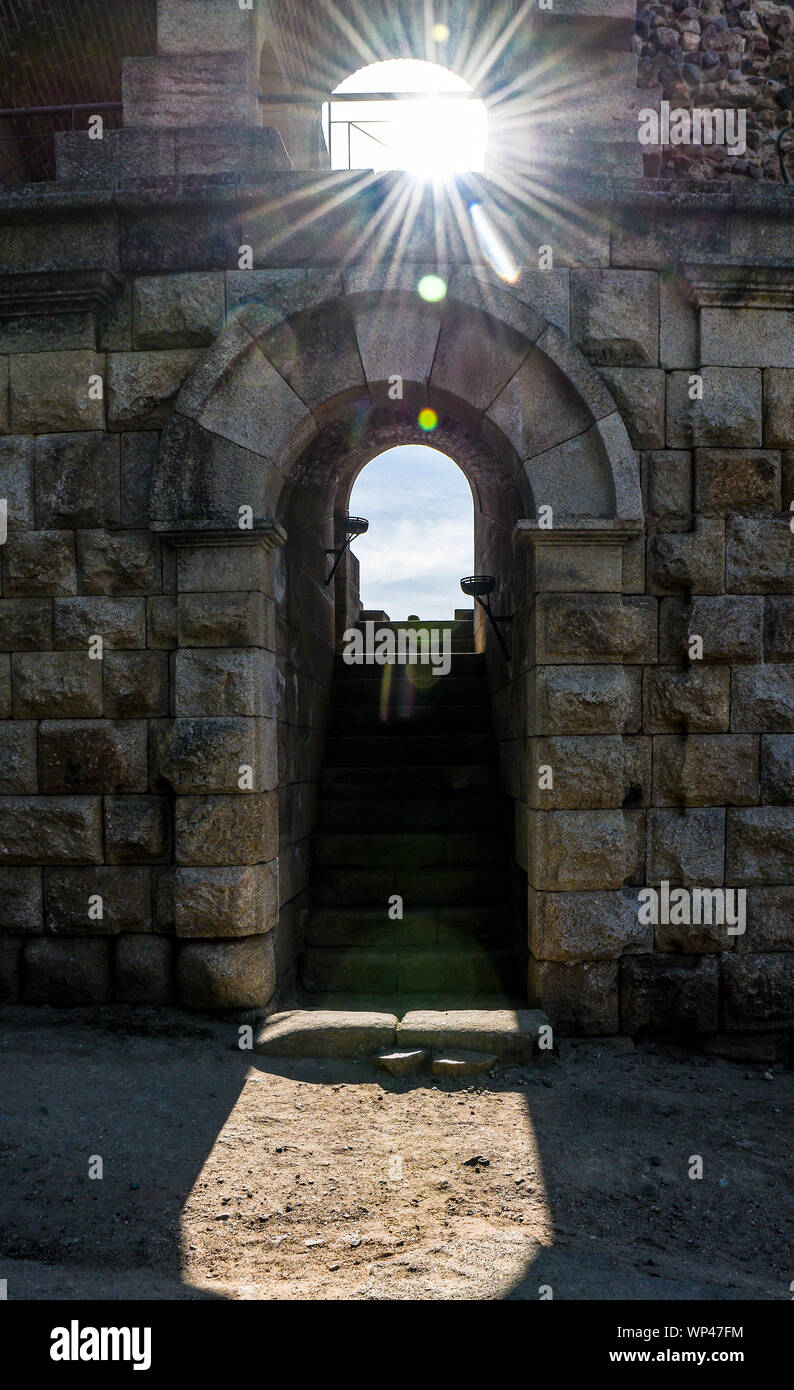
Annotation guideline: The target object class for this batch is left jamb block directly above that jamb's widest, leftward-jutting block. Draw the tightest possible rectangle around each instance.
[174,648,278,716]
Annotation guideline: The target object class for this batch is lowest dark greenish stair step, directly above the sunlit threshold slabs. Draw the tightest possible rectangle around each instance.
[300,947,517,995]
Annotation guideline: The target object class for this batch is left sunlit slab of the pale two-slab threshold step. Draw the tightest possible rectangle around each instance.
[253,1009,400,1056]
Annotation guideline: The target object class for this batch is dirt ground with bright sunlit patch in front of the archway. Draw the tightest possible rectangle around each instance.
[0,1009,794,1300]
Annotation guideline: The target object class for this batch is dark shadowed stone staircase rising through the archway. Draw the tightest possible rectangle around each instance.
[300,612,521,1012]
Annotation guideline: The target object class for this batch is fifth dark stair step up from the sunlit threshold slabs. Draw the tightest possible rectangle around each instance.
[317,796,505,834]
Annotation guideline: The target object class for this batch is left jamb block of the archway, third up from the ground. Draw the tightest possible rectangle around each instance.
[174,791,278,866]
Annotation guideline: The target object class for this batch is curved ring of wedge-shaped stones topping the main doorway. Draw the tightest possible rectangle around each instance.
[152,265,642,531]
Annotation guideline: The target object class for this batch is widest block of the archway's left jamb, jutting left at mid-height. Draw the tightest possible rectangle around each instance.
[153,719,278,795]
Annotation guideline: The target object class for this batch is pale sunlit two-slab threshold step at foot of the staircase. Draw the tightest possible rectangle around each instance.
[253,1008,551,1062]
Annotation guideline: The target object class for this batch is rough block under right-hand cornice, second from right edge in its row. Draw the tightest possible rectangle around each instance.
[667,367,762,449]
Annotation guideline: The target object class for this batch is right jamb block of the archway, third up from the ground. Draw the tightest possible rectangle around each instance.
[528,810,645,892]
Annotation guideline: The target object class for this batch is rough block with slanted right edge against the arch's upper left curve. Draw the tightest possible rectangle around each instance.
[107,352,199,430]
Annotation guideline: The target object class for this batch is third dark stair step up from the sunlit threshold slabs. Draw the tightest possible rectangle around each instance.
[313,865,509,912]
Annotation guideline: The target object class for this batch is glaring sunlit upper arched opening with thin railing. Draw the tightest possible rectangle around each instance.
[323,58,488,179]
